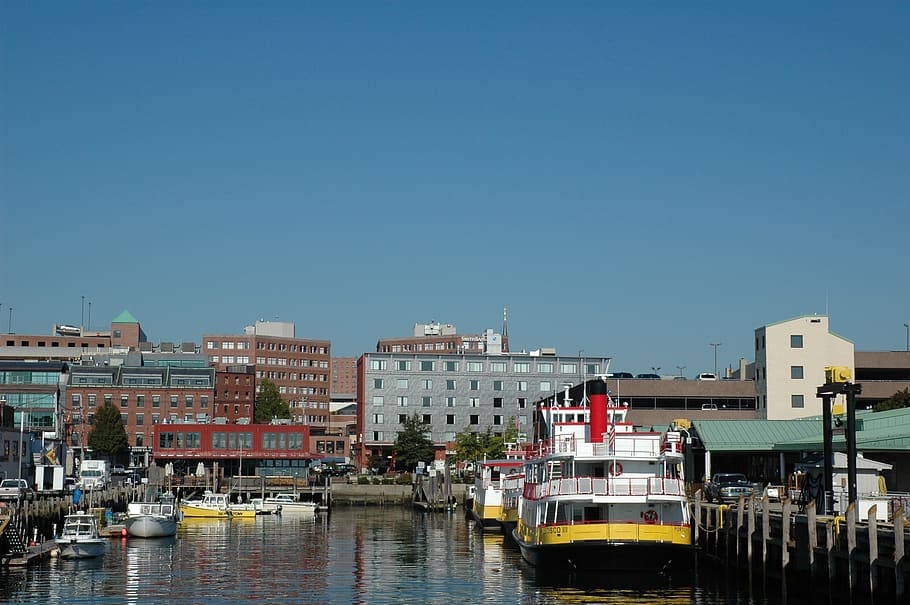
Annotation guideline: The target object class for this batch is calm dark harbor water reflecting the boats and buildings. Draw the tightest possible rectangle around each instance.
[0,506,780,605]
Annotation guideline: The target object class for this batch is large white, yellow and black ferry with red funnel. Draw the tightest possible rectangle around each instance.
[512,379,695,573]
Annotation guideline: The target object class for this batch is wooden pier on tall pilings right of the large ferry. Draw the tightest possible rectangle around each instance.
[693,494,910,603]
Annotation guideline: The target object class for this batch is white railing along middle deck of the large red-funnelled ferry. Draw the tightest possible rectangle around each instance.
[524,477,686,499]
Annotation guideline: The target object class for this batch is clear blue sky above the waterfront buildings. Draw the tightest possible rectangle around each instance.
[0,0,910,376]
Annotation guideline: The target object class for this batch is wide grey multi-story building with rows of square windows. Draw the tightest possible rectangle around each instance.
[357,353,608,464]
